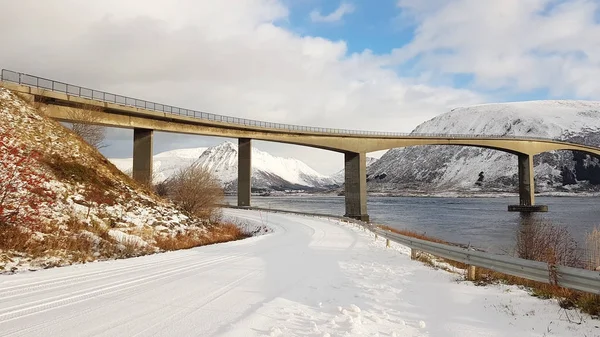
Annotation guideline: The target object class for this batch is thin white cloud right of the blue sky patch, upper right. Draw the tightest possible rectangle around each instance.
[394,0,600,99]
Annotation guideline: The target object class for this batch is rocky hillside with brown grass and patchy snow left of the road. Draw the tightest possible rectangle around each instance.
[0,88,244,273]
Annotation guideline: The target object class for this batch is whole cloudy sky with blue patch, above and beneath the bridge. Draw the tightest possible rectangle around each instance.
[0,0,600,174]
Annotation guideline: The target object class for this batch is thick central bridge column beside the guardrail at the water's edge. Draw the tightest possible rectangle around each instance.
[344,152,369,221]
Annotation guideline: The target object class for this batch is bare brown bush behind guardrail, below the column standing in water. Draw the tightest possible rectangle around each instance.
[516,219,583,268]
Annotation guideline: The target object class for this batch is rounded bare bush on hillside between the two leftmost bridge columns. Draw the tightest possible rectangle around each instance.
[161,165,224,219]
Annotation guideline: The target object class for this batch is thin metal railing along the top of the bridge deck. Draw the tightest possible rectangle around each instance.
[0,69,592,145]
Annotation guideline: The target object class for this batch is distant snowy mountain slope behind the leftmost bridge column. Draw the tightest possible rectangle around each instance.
[109,147,206,182]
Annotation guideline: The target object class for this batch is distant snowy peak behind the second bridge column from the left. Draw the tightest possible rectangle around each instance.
[197,142,336,190]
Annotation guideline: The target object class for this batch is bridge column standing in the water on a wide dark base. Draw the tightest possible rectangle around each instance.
[508,154,548,212]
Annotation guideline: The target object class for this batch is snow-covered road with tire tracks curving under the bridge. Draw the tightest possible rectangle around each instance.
[0,210,600,336]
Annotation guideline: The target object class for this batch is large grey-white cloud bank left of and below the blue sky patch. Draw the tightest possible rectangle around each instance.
[0,0,482,173]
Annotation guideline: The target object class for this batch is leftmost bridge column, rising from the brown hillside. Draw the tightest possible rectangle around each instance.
[133,129,154,185]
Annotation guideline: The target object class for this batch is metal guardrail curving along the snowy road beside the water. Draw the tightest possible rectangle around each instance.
[223,205,600,295]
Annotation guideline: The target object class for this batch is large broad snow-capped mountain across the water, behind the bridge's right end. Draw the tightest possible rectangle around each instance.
[367,101,600,193]
